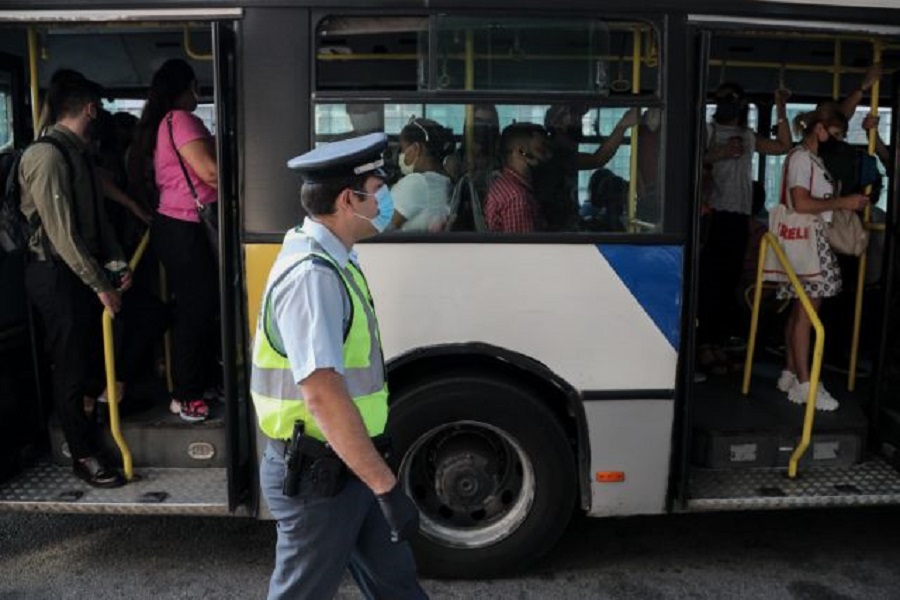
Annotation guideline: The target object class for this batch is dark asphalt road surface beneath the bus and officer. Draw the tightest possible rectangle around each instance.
[0,508,900,600]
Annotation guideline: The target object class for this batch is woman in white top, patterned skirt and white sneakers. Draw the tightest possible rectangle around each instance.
[777,111,869,411]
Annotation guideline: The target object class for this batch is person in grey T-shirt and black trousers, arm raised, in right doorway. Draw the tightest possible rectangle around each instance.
[697,83,791,374]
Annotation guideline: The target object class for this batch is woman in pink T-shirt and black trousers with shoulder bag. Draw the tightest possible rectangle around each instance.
[138,59,218,422]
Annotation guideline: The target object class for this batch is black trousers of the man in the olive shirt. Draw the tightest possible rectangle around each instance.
[25,261,103,459]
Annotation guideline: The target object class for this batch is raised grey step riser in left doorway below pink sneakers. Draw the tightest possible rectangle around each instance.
[50,402,226,469]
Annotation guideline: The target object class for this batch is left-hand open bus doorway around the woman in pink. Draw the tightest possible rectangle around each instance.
[0,10,253,515]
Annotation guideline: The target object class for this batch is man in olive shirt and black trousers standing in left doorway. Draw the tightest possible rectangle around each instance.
[18,72,131,487]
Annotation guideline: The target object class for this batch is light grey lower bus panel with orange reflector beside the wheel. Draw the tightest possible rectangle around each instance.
[584,399,675,517]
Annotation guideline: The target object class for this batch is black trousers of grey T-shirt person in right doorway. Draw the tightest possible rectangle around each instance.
[697,211,750,344]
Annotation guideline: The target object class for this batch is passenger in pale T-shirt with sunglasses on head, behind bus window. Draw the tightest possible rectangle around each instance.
[391,119,454,232]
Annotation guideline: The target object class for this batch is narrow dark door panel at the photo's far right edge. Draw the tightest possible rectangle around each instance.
[876,69,900,466]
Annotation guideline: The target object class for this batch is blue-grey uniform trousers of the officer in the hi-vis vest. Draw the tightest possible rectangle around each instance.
[260,443,428,600]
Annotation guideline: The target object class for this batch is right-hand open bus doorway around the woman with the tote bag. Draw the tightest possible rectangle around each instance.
[683,23,900,510]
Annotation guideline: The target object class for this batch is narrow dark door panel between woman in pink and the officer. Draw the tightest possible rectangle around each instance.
[213,22,256,512]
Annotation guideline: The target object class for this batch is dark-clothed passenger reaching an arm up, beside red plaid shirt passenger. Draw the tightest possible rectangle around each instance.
[534,104,640,231]
